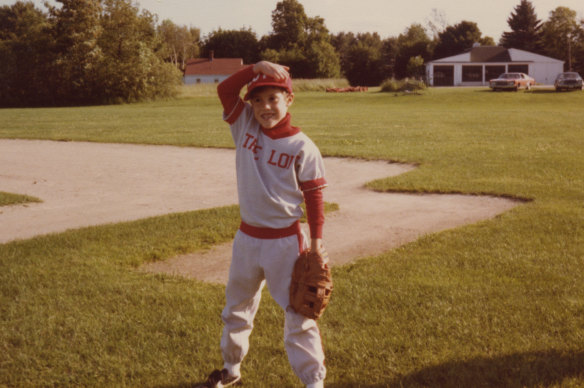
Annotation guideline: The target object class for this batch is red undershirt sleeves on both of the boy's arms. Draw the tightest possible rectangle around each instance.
[217,65,324,238]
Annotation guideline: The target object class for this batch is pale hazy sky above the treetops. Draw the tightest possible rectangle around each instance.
[0,0,584,42]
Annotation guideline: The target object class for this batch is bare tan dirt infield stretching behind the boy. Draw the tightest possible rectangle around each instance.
[0,140,518,283]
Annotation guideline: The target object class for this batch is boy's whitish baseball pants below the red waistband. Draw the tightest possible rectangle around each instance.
[221,224,326,384]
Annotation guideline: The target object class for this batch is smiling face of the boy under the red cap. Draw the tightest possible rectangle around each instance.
[249,86,294,129]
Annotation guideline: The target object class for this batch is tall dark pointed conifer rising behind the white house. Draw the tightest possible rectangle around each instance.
[499,0,542,53]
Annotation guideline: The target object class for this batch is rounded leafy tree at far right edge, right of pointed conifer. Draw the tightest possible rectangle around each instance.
[541,7,582,70]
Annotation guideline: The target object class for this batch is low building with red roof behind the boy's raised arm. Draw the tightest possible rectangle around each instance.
[183,52,244,85]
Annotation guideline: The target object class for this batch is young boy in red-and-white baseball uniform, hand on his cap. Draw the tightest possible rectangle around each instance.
[203,61,327,388]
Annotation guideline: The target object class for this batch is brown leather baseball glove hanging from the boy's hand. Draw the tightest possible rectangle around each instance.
[290,249,333,319]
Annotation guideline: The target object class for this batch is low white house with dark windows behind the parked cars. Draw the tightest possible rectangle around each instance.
[426,46,564,86]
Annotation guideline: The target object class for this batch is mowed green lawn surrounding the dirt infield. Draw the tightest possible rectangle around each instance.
[0,88,584,387]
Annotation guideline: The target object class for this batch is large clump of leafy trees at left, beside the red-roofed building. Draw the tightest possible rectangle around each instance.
[0,0,181,106]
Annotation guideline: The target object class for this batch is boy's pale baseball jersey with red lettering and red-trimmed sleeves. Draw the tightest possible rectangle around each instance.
[223,104,326,229]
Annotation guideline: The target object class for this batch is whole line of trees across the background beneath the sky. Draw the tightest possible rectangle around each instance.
[0,0,584,106]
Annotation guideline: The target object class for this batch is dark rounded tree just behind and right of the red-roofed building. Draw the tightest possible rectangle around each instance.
[201,28,260,63]
